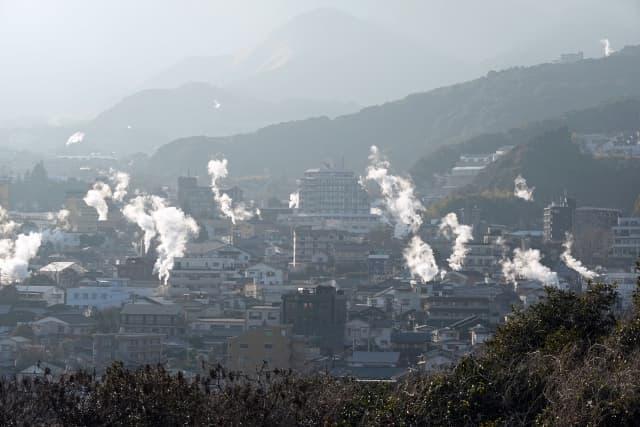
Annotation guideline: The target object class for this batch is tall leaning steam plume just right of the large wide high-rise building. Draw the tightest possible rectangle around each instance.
[366,145,424,238]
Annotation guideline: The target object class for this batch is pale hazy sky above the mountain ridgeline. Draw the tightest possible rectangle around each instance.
[0,0,640,121]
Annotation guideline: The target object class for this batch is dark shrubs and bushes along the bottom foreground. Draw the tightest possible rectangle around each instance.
[0,264,640,426]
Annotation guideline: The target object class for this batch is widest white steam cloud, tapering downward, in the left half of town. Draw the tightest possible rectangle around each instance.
[122,195,198,285]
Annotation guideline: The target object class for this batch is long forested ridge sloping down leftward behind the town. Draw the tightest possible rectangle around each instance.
[149,47,640,182]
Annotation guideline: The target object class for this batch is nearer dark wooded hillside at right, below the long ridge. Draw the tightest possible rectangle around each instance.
[422,98,640,227]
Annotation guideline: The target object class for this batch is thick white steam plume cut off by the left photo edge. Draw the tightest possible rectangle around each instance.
[0,233,42,283]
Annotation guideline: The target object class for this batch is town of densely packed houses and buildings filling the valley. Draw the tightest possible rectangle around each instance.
[0,166,640,380]
